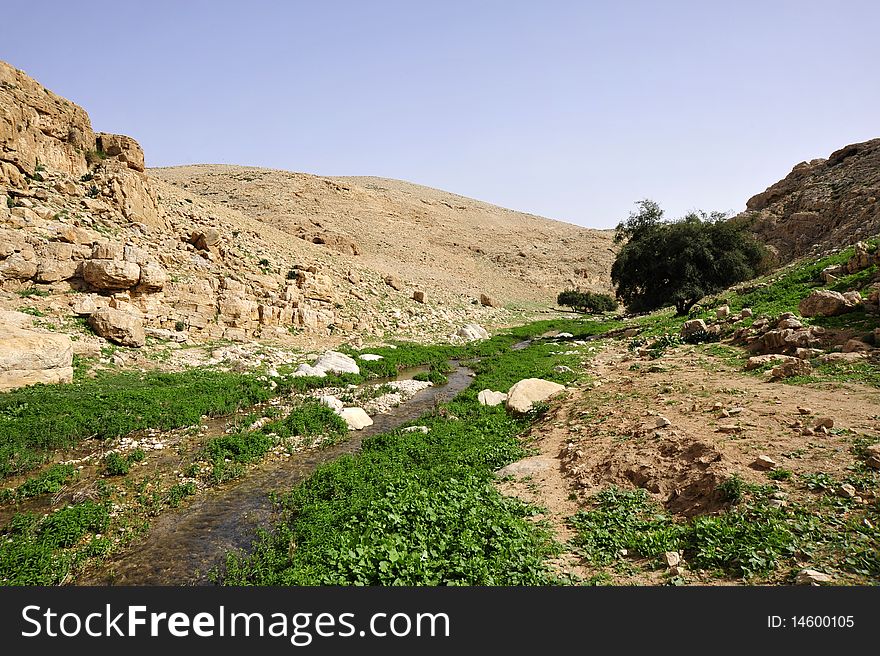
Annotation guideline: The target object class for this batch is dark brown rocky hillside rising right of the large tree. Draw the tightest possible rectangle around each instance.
[736,139,880,262]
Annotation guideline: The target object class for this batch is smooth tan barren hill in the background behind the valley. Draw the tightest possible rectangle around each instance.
[150,165,613,303]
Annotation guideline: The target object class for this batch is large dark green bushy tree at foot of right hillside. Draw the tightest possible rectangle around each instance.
[611,199,766,314]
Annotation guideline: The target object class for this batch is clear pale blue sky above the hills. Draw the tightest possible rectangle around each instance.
[0,0,880,227]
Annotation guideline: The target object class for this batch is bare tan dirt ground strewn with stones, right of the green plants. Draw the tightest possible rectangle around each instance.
[500,340,880,583]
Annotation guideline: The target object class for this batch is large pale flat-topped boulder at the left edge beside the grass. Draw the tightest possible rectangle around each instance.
[0,322,73,392]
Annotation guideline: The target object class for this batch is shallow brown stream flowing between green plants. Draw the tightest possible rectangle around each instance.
[79,363,472,585]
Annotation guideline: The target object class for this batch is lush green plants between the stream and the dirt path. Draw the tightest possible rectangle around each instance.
[215,321,616,585]
